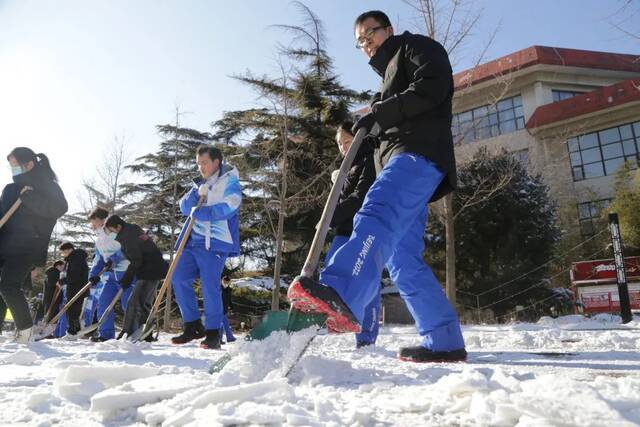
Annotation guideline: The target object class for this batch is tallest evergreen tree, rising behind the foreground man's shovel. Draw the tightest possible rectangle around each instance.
[213,3,368,273]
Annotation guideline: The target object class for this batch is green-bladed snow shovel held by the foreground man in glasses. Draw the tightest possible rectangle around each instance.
[209,129,366,375]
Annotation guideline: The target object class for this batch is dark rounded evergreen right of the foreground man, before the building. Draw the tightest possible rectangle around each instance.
[454,149,560,315]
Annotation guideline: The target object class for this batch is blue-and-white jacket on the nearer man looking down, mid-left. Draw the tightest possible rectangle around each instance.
[176,164,242,256]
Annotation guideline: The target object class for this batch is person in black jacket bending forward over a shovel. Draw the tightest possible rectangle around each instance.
[104,215,167,338]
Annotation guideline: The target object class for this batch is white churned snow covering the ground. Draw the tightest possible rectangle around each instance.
[0,315,640,426]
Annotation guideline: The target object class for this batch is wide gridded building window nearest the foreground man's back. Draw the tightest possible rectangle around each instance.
[451,95,524,143]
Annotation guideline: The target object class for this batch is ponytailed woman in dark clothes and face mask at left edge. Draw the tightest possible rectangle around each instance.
[0,147,68,343]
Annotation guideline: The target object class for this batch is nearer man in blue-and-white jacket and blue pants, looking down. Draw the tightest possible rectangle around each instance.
[171,145,242,349]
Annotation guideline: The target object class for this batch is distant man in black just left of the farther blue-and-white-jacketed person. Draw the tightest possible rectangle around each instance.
[59,242,89,339]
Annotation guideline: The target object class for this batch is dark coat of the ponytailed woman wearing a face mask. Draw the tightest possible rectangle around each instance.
[0,167,68,266]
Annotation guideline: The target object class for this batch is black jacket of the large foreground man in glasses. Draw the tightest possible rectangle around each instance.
[369,32,456,202]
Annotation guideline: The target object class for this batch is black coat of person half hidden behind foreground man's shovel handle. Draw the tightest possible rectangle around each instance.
[331,141,376,236]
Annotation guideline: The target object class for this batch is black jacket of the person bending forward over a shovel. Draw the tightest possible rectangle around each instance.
[116,224,167,286]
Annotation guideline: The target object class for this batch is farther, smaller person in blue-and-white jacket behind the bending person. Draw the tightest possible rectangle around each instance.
[87,207,135,342]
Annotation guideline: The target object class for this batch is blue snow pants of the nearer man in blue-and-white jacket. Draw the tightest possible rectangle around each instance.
[173,239,227,330]
